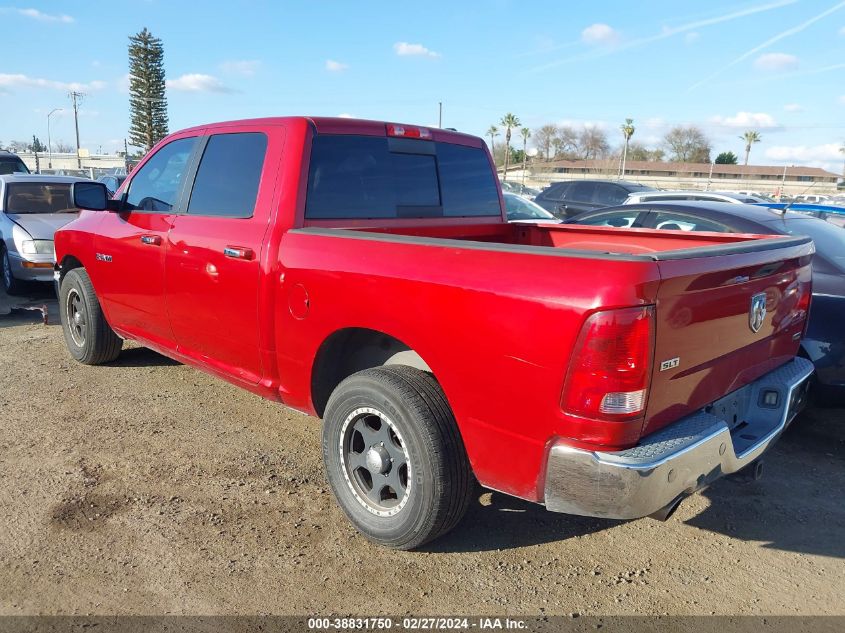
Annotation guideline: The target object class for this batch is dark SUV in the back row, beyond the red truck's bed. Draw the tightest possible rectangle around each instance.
[534,180,654,219]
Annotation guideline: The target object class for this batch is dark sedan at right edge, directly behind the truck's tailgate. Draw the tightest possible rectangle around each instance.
[567,202,845,405]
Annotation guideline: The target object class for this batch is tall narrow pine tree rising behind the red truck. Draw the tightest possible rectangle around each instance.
[129,28,167,151]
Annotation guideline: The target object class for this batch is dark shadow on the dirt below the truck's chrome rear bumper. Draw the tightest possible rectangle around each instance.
[432,409,845,558]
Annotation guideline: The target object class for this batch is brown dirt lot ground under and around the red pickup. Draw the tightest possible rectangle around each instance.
[0,286,845,615]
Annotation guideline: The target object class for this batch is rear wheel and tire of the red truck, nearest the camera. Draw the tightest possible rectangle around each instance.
[323,365,475,550]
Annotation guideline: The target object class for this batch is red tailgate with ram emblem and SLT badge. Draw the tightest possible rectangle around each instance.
[643,237,813,435]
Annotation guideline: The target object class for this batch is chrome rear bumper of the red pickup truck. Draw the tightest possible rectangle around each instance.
[545,358,813,519]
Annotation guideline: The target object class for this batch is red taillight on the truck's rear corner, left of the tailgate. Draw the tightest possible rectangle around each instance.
[561,306,654,421]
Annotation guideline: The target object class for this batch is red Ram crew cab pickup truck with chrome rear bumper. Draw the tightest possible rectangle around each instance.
[56,117,813,549]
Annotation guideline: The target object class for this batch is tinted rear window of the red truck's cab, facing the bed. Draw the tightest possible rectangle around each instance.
[305,134,502,220]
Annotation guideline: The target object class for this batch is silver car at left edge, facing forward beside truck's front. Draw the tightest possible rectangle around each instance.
[0,174,90,294]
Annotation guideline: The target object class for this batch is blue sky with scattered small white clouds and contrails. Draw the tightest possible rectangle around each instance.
[0,0,845,173]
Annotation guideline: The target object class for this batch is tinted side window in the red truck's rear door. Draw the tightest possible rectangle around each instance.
[188,132,267,218]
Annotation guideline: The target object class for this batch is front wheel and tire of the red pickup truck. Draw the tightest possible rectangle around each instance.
[59,268,123,365]
